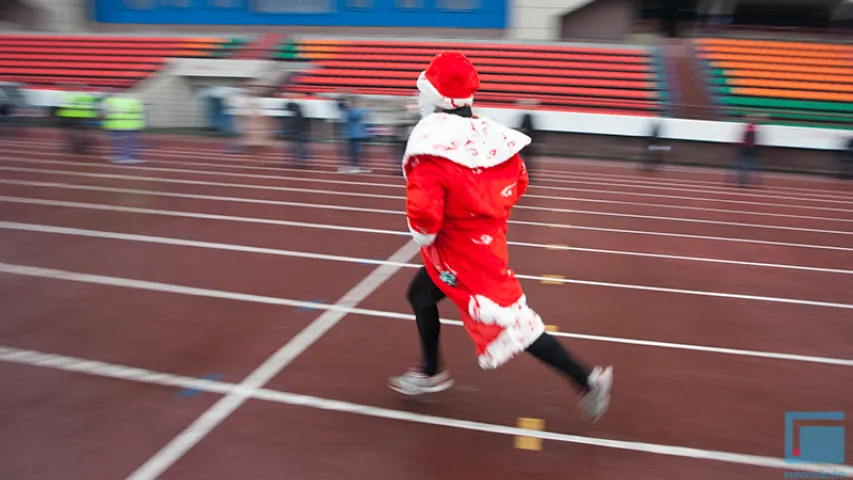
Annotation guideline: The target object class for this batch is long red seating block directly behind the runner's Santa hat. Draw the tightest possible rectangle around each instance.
[275,38,666,115]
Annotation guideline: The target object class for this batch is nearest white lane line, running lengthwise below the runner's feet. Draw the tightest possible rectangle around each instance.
[0,347,853,478]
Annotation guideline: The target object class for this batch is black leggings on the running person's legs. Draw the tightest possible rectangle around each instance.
[408,267,589,391]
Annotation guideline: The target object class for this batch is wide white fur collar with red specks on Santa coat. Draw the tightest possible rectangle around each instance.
[403,113,531,174]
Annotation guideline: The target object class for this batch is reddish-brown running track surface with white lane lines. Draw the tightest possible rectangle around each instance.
[0,132,853,480]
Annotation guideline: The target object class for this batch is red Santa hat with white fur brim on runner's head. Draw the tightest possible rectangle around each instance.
[418,52,480,110]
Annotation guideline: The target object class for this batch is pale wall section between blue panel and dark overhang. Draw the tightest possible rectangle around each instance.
[507,0,595,41]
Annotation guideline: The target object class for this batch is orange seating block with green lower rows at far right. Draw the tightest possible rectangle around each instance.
[694,38,853,127]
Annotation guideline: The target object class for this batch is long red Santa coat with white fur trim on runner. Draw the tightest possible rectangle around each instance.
[403,110,545,369]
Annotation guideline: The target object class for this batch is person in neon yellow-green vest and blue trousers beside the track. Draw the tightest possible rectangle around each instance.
[103,95,145,163]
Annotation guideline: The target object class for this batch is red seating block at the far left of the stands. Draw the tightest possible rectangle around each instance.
[0,35,246,88]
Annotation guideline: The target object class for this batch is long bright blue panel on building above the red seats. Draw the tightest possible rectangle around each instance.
[95,0,508,29]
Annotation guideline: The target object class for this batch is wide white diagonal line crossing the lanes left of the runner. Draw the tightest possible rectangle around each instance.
[122,241,420,480]
